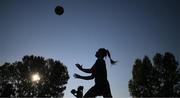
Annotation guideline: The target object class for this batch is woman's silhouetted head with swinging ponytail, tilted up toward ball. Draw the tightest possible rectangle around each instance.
[95,48,117,64]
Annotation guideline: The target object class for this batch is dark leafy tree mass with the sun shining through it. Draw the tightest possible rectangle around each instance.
[0,55,69,97]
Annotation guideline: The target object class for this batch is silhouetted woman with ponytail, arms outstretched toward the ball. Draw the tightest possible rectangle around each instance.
[74,48,116,98]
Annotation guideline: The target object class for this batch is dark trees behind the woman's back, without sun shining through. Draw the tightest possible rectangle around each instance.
[129,52,180,97]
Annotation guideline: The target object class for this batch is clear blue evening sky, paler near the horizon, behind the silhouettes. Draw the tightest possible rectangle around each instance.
[0,0,180,98]
